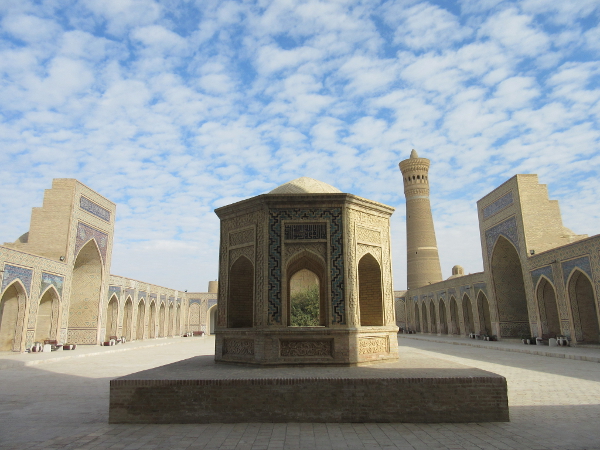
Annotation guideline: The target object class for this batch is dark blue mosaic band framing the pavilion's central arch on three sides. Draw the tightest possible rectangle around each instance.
[268,208,346,325]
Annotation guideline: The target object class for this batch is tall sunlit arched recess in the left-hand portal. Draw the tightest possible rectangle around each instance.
[67,239,102,344]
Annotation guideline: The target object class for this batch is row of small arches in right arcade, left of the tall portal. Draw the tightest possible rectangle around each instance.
[413,291,493,335]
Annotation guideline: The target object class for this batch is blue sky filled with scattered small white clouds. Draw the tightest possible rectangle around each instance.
[0,0,600,291]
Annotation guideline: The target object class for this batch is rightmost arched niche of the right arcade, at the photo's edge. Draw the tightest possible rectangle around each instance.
[567,269,600,344]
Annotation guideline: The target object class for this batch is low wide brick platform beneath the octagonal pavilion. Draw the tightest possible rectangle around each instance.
[109,354,509,423]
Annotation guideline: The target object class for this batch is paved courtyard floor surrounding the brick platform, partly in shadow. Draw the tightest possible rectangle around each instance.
[0,335,600,450]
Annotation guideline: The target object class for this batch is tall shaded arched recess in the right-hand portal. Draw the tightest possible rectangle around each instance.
[491,236,530,338]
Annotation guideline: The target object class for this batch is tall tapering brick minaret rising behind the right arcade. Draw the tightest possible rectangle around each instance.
[400,149,442,289]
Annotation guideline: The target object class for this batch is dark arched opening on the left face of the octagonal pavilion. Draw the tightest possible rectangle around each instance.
[227,256,254,328]
